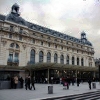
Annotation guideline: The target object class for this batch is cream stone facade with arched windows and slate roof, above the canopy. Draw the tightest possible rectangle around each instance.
[0,3,95,67]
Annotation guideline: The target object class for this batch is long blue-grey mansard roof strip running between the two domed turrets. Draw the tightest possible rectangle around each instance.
[0,14,92,46]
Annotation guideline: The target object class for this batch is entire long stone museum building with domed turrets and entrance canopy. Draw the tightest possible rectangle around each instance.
[0,3,98,83]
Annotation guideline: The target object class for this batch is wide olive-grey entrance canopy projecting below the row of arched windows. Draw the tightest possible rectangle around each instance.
[24,63,98,71]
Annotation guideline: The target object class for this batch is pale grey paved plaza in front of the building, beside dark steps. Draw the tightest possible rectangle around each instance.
[0,82,100,100]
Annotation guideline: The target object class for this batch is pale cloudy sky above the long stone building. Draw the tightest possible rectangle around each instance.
[0,0,100,58]
